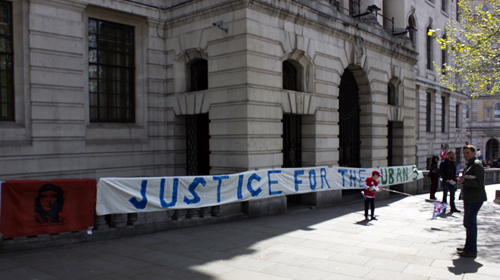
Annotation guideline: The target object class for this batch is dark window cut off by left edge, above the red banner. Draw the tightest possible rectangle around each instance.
[0,1,14,121]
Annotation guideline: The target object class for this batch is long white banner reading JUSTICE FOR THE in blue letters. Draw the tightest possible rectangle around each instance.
[96,165,423,215]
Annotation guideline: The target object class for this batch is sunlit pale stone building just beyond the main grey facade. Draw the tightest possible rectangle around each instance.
[410,0,468,169]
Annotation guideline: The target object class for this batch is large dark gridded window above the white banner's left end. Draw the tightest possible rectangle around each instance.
[88,19,135,123]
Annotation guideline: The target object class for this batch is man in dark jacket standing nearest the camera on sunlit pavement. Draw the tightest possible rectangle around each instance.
[457,145,486,258]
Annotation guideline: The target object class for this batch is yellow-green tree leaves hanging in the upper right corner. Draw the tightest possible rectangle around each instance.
[427,0,500,96]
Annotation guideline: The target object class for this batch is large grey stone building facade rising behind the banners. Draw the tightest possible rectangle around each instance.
[0,0,418,196]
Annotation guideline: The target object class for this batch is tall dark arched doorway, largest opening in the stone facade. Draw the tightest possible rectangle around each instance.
[339,69,361,167]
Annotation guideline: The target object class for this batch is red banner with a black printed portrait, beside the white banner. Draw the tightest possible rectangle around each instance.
[0,179,97,238]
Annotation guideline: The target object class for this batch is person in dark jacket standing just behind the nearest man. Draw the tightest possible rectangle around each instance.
[439,151,460,213]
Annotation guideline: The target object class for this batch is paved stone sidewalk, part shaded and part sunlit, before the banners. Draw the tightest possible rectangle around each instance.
[0,185,500,280]
